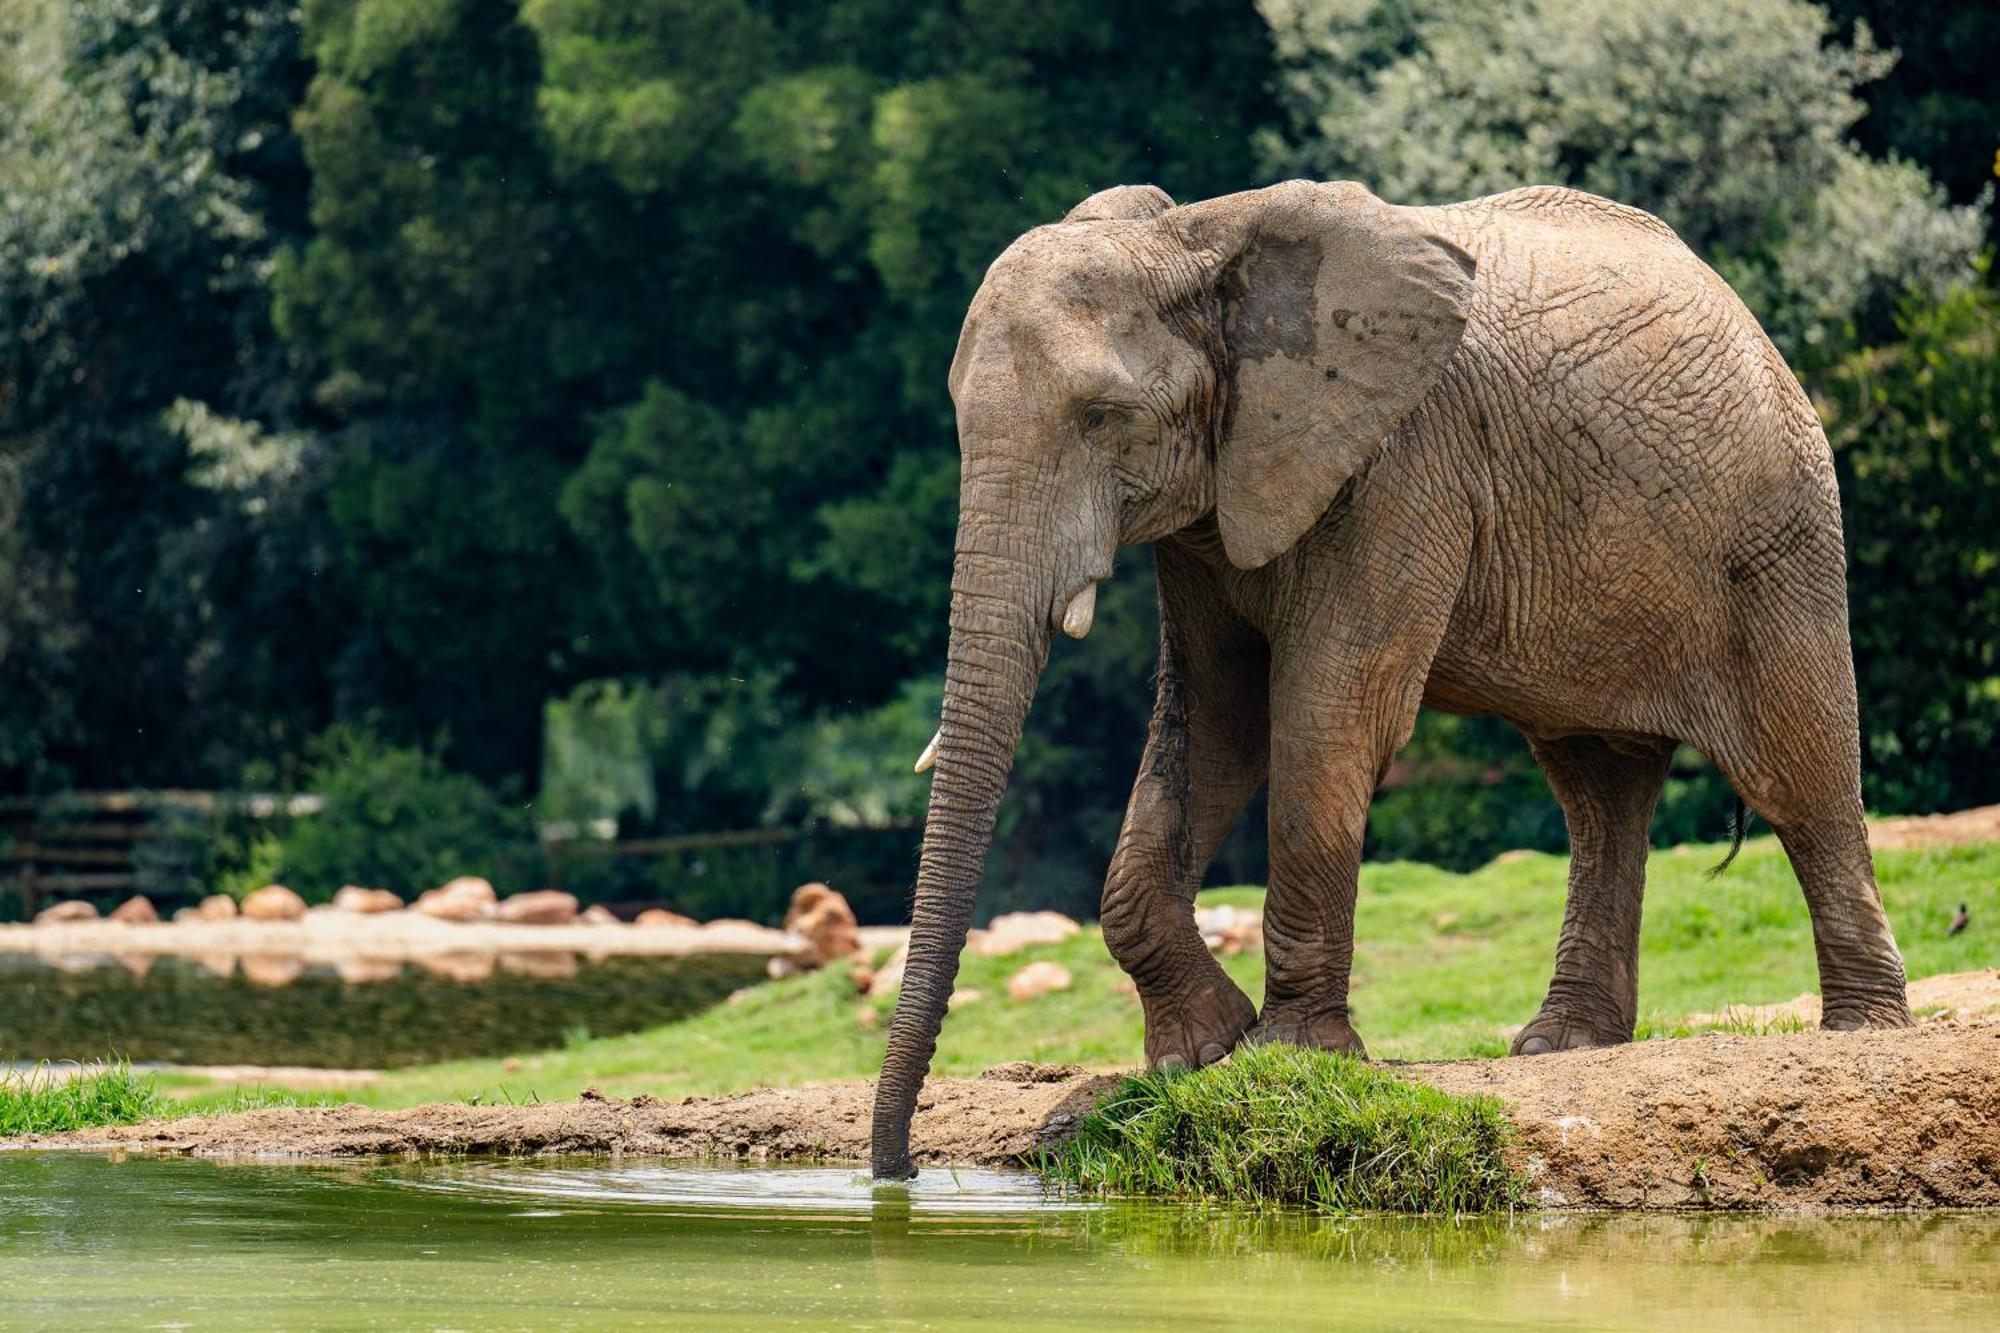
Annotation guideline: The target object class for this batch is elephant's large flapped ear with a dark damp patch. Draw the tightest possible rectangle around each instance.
[1174,180,1474,568]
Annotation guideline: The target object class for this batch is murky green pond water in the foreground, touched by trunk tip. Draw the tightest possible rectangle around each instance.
[0,1153,2000,1333]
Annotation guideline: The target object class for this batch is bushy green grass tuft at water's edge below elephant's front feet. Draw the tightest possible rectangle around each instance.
[1038,1045,1522,1213]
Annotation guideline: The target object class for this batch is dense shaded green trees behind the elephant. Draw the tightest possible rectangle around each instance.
[0,0,2000,919]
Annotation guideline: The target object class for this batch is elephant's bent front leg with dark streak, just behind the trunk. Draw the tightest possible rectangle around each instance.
[1100,550,1268,1069]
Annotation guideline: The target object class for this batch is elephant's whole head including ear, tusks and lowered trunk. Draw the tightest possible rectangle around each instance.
[872,182,1472,1177]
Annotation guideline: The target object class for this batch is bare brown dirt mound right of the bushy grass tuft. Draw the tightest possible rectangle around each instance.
[1402,1023,2000,1209]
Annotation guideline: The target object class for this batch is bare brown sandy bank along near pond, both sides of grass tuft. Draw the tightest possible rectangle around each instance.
[19,1023,2000,1209]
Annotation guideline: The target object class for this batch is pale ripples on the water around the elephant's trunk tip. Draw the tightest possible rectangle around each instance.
[386,1163,1098,1219]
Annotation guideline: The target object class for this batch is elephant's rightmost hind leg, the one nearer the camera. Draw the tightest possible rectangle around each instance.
[1702,612,1910,1029]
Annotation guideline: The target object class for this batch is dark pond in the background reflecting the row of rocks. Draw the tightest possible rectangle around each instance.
[0,955,764,1069]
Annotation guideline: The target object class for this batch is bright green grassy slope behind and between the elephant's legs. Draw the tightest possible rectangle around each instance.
[296,839,2000,1107]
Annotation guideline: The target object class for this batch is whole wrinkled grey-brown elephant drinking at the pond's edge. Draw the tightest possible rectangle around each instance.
[872,180,1910,1179]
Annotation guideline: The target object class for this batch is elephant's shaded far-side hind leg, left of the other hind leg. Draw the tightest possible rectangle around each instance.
[1512,737,1674,1055]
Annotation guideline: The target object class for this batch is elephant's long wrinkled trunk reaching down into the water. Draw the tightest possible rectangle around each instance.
[870,506,1054,1179]
